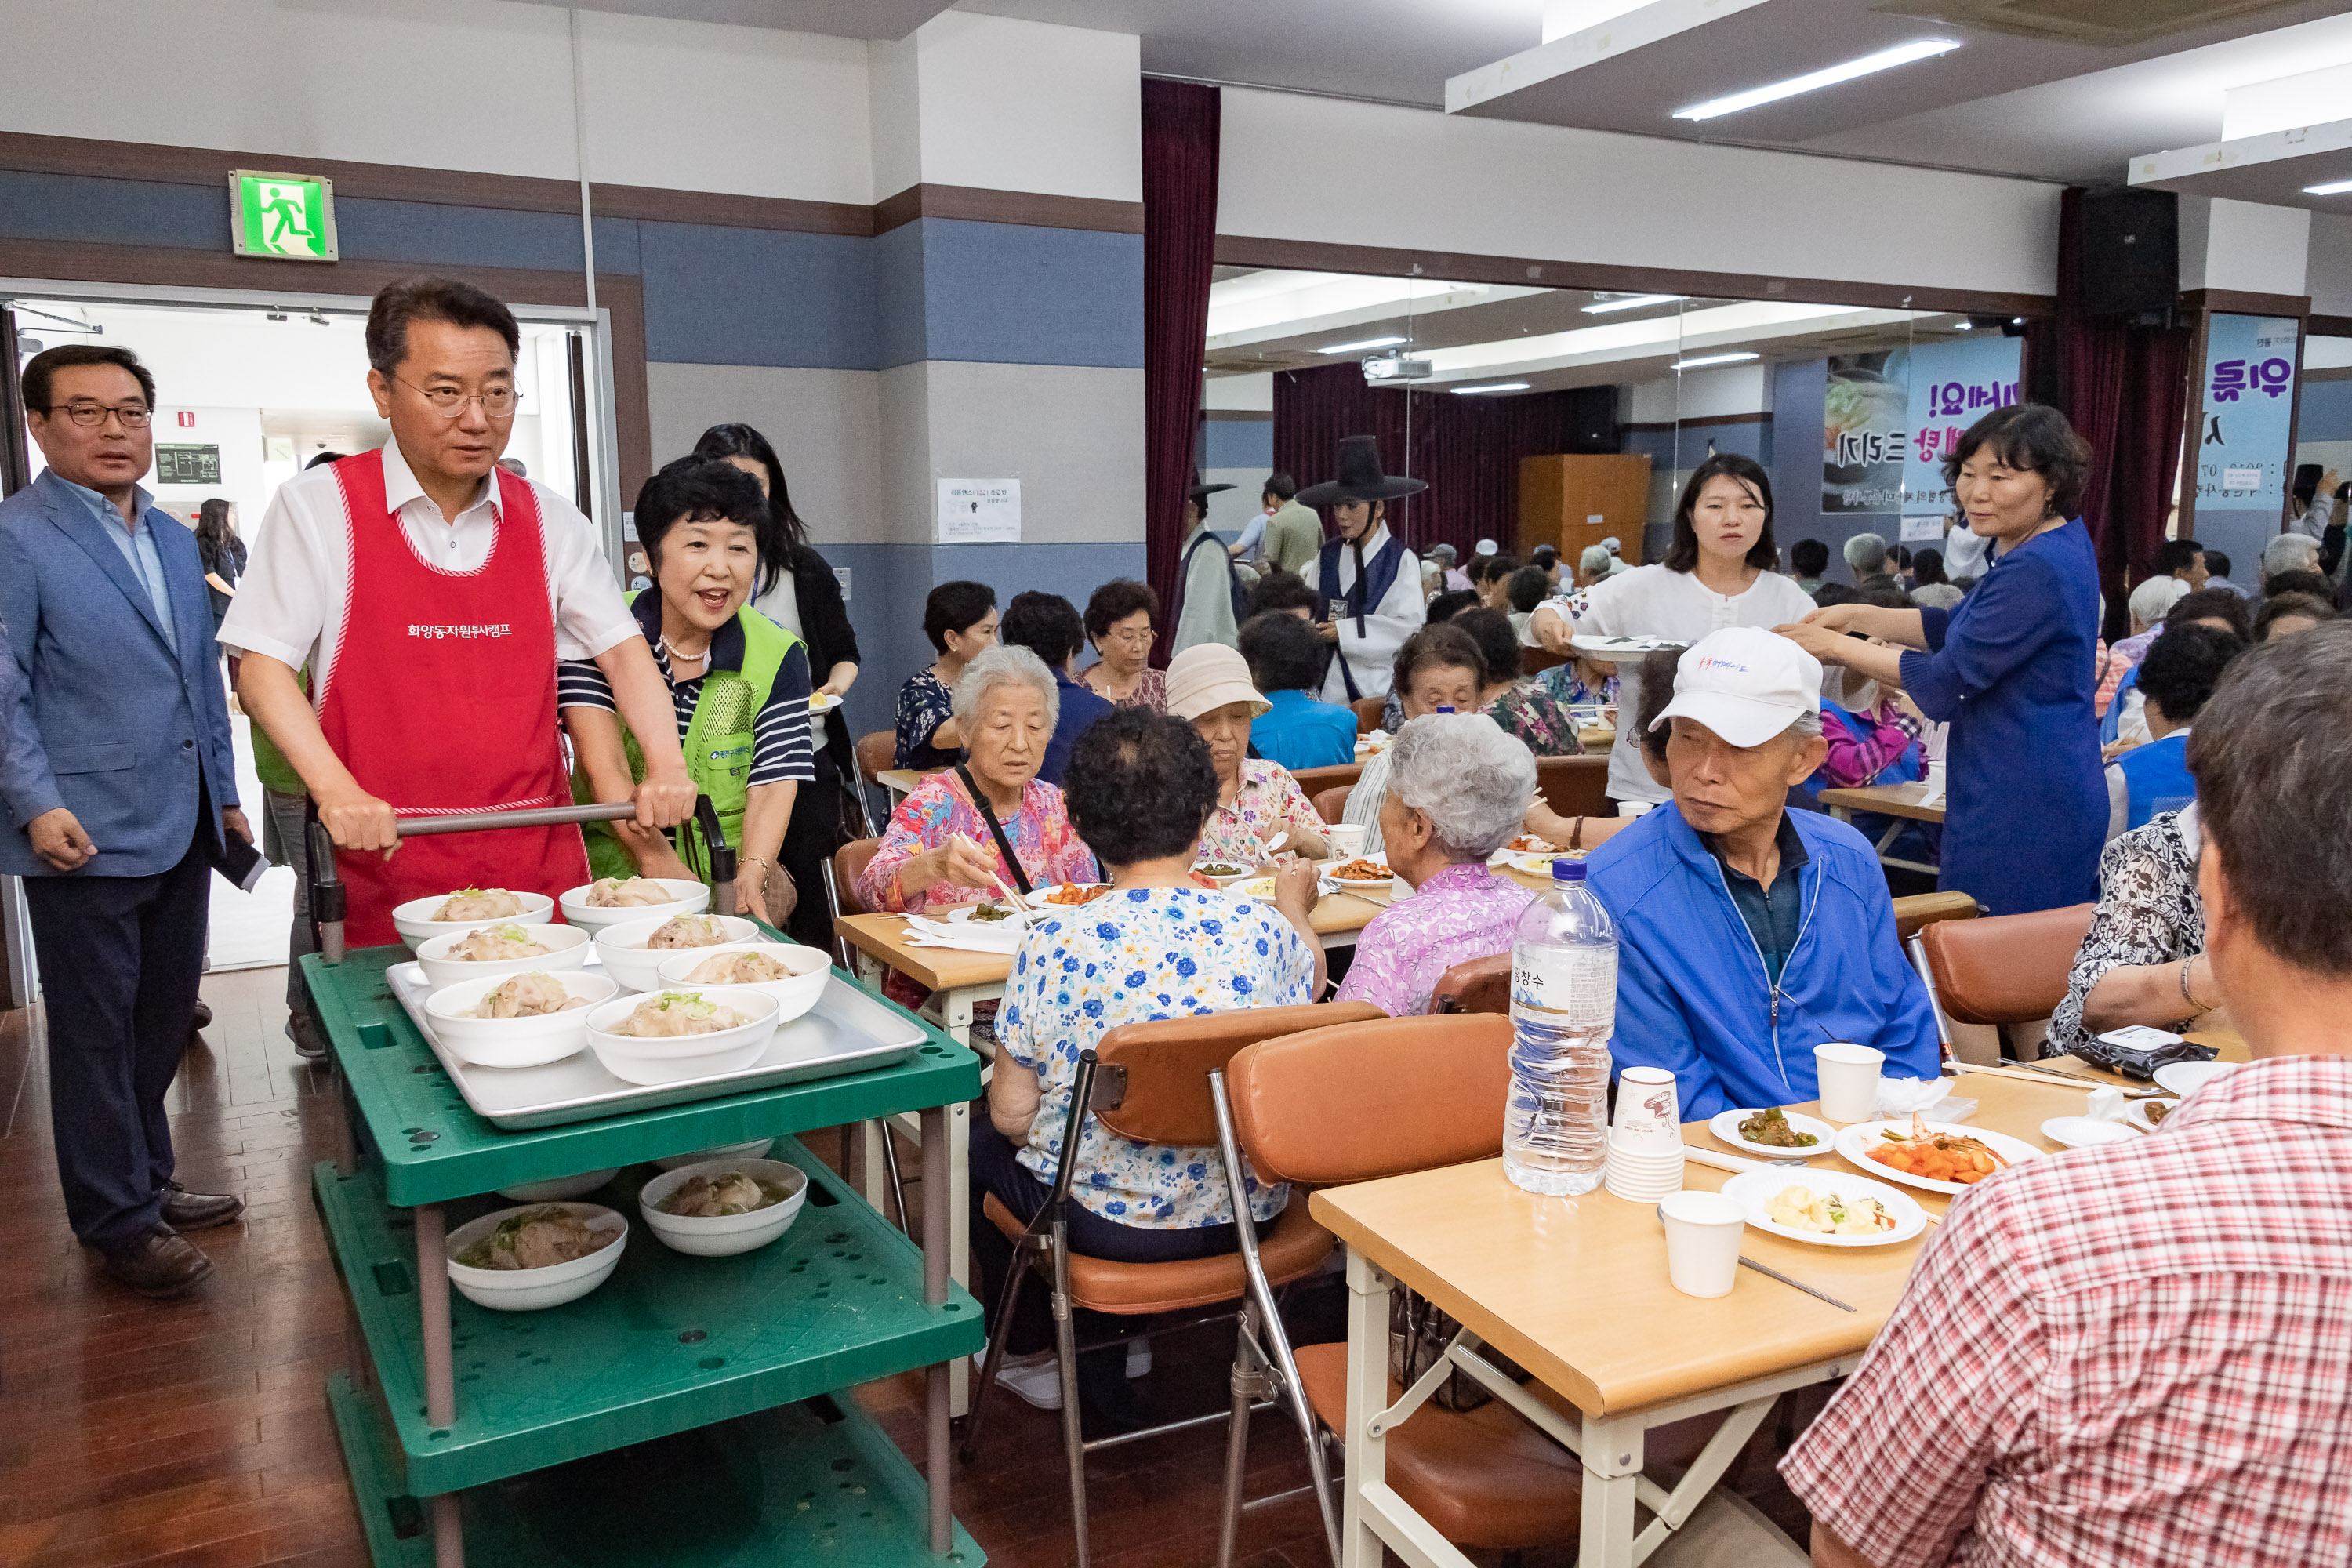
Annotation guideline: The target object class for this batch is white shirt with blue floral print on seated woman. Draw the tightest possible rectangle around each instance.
[997,888,1315,1229]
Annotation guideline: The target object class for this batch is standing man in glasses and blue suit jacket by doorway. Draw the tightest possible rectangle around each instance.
[0,343,252,1295]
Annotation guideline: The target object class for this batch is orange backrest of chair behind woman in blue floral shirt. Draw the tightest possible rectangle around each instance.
[1094,1001,1383,1147]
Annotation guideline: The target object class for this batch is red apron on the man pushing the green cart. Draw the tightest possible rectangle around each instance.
[318,452,588,947]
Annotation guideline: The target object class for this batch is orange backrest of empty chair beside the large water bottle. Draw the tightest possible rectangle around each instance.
[1225,1013,1510,1187]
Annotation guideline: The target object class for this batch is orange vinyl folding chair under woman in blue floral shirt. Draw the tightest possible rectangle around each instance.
[957,1001,1383,1568]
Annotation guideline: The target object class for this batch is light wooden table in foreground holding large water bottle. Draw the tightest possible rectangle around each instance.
[1310,1074,2126,1568]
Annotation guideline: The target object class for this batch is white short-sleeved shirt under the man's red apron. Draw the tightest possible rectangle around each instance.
[221,442,642,701]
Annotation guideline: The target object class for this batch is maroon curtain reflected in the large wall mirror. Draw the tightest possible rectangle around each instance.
[1275,365,1616,560]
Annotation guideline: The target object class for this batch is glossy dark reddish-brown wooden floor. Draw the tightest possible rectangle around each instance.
[0,968,1327,1568]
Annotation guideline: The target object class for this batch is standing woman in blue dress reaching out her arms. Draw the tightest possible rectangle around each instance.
[1778,402,2107,914]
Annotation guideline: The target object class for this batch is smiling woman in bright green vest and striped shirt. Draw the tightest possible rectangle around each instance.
[555,459,816,926]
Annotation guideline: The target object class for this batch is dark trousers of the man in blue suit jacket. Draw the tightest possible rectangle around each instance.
[24,801,212,1250]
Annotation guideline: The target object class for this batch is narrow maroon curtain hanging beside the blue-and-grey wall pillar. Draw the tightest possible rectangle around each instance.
[1143,78,1218,644]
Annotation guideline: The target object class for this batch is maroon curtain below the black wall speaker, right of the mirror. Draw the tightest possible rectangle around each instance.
[2025,188,2190,642]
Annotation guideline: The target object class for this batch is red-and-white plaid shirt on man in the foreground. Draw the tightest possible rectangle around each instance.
[1780,1055,2352,1568]
